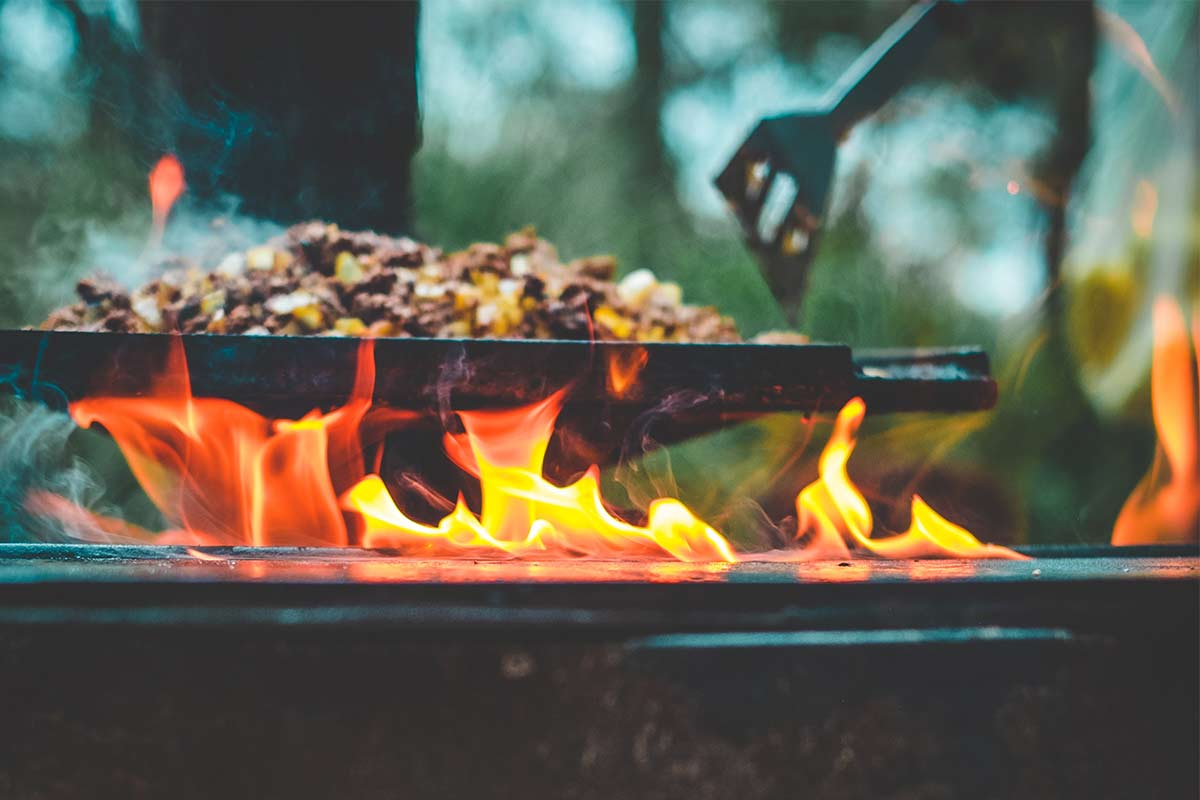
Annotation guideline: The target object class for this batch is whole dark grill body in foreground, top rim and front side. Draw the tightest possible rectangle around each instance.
[0,546,1200,798]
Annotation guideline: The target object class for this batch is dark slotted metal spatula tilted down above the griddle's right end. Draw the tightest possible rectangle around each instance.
[715,1,958,325]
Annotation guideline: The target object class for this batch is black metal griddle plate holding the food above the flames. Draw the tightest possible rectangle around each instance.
[0,331,996,416]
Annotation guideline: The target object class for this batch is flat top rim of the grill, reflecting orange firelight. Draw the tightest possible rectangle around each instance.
[0,545,1200,636]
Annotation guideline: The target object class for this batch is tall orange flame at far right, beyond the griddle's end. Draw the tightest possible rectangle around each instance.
[1112,296,1200,545]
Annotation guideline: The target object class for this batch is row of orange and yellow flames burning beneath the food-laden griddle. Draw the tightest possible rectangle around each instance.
[28,337,1020,564]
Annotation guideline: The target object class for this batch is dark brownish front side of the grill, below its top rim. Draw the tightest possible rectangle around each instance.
[0,626,1200,800]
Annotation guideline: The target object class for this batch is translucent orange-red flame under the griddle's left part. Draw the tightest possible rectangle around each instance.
[71,338,374,546]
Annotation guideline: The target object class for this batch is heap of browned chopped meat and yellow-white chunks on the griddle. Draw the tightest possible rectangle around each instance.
[42,222,740,342]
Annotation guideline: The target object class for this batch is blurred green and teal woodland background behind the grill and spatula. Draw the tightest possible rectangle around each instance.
[0,0,1200,543]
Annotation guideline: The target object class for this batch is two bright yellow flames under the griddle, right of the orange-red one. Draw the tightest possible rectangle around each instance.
[342,397,1024,563]
